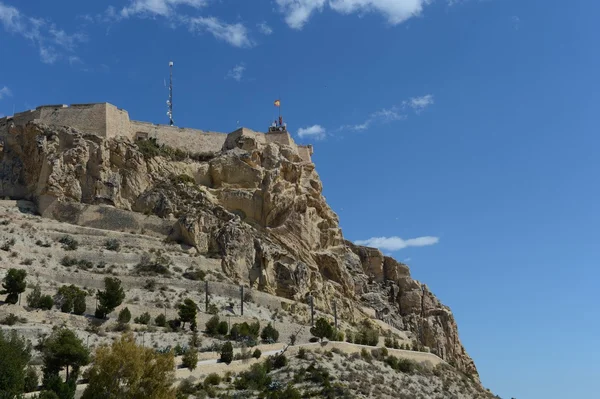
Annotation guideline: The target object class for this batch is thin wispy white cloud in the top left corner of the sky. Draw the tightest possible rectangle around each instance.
[0,2,87,64]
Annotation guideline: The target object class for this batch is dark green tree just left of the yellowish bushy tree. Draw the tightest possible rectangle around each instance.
[37,328,90,399]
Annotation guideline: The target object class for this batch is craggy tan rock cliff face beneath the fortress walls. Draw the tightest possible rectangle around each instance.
[0,122,478,378]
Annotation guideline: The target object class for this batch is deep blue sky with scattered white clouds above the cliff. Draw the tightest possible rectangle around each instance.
[0,0,600,399]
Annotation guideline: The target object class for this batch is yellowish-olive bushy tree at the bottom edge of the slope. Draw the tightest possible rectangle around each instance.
[82,333,176,399]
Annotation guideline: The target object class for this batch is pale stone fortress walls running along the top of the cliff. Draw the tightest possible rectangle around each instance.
[0,103,313,162]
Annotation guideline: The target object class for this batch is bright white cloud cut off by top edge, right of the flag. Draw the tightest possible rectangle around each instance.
[276,0,436,29]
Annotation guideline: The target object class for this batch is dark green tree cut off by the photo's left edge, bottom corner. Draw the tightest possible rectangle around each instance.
[0,330,31,398]
